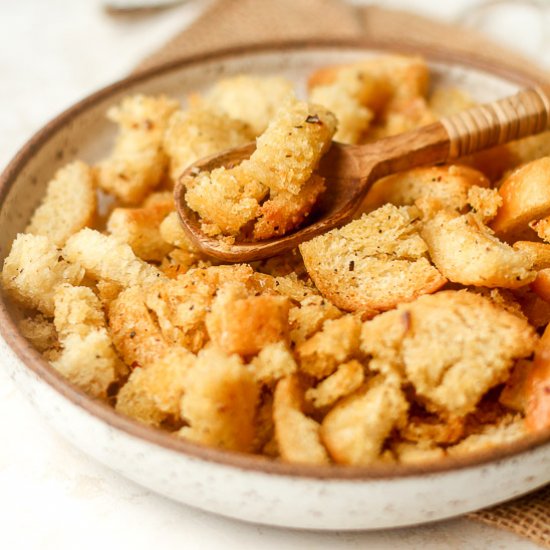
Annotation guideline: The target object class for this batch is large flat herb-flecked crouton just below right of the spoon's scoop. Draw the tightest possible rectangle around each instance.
[300,204,446,314]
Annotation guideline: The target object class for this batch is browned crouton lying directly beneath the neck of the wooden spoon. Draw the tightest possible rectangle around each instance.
[361,165,490,211]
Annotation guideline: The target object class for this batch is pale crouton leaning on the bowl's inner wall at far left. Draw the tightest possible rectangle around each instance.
[25,161,96,246]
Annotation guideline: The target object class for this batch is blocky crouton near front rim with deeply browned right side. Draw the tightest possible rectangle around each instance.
[179,348,258,452]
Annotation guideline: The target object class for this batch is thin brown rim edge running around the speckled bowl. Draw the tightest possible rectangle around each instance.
[0,38,550,481]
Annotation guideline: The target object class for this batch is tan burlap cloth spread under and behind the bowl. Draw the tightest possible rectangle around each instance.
[130,0,550,548]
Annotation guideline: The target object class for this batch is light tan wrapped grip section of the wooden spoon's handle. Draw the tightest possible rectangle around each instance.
[440,86,550,160]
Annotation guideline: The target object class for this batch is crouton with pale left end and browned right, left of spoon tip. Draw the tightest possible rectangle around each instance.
[107,203,173,261]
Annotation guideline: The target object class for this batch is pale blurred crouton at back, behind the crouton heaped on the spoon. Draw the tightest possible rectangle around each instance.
[199,75,294,137]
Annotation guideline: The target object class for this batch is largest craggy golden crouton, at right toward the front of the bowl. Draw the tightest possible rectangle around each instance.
[361,291,537,416]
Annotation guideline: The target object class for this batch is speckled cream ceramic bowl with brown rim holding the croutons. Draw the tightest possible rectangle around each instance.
[0,43,550,530]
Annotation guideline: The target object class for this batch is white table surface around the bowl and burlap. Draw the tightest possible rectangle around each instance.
[0,0,548,550]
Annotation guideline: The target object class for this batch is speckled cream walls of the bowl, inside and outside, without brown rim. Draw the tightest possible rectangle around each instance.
[0,49,550,530]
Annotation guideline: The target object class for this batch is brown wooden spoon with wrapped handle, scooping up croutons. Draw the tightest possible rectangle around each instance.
[175,86,550,262]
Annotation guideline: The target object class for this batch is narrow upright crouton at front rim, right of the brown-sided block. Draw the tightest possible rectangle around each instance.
[273,375,329,464]
